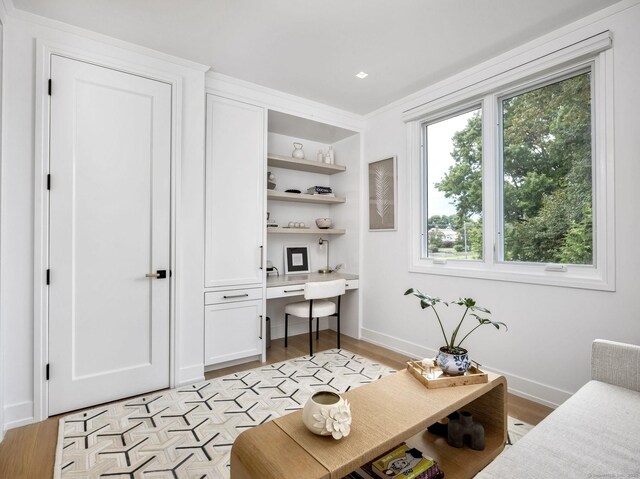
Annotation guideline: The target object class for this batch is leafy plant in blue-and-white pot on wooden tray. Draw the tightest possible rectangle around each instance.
[404,288,507,375]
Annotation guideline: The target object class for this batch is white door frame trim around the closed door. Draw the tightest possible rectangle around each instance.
[33,39,182,421]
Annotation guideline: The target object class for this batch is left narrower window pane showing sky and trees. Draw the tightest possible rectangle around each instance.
[422,107,482,260]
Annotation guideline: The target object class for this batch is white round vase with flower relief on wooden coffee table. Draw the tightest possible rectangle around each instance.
[302,391,351,439]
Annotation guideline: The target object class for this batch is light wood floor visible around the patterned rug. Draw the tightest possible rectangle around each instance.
[0,331,552,479]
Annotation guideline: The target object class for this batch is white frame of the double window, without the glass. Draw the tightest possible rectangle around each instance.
[410,31,615,291]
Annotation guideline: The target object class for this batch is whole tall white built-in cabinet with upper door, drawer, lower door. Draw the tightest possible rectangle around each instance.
[204,94,266,366]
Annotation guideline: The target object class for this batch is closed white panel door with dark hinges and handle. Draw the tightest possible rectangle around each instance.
[49,55,171,415]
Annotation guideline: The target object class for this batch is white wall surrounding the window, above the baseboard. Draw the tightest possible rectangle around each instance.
[361,2,640,405]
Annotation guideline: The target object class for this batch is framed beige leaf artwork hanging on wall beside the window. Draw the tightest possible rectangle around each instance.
[369,156,398,231]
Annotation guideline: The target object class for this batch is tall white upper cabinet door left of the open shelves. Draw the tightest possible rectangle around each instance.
[205,95,265,287]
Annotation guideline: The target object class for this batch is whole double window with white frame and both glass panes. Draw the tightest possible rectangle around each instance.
[404,32,615,291]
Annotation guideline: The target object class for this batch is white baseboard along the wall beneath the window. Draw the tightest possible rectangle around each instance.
[360,328,572,408]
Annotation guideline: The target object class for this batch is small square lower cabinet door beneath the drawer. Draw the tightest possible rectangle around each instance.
[204,300,263,366]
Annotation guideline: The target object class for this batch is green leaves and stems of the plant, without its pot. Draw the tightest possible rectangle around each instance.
[404,288,507,354]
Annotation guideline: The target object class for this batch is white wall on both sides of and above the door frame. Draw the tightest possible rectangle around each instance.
[0,14,206,428]
